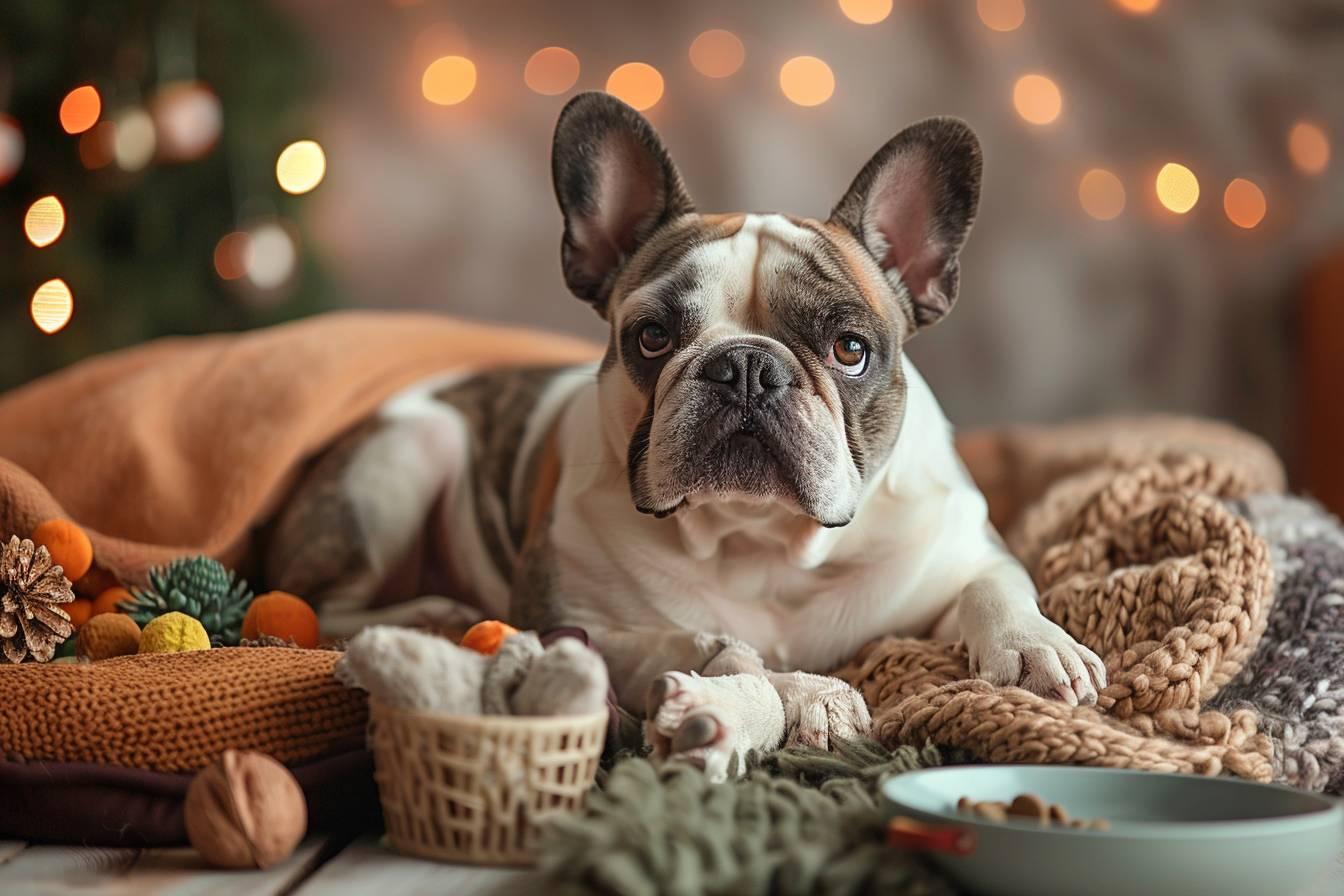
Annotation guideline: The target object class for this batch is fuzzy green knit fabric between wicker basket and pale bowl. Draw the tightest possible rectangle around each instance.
[542,743,953,896]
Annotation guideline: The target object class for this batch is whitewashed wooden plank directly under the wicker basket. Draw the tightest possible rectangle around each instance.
[296,834,542,896]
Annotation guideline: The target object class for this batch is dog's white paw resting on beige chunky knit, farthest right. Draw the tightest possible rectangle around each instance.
[966,617,1106,707]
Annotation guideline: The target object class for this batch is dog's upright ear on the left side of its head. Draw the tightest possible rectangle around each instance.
[551,93,695,316]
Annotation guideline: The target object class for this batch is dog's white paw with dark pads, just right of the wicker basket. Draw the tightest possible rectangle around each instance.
[644,672,784,782]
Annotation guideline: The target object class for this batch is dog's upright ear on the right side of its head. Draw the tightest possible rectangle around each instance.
[831,118,981,328]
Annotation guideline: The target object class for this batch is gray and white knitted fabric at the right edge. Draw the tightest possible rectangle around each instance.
[1211,494,1344,794]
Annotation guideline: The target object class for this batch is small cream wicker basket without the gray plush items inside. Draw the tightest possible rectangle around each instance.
[370,700,607,865]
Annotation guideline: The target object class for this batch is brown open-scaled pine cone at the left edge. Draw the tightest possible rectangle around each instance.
[0,535,75,662]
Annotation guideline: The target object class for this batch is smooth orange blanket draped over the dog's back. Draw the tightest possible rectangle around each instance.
[0,312,599,592]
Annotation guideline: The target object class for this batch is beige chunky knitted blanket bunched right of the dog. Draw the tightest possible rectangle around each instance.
[835,418,1284,780]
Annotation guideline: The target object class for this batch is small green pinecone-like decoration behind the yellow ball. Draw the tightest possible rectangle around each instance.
[120,556,253,647]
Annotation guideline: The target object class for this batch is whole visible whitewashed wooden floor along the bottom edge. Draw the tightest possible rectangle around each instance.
[0,836,1344,896]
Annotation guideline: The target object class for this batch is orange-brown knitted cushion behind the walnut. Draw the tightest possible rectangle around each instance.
[0,647,368,772]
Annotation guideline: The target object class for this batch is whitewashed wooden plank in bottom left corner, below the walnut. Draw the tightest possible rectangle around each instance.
[0,837,329,896]
